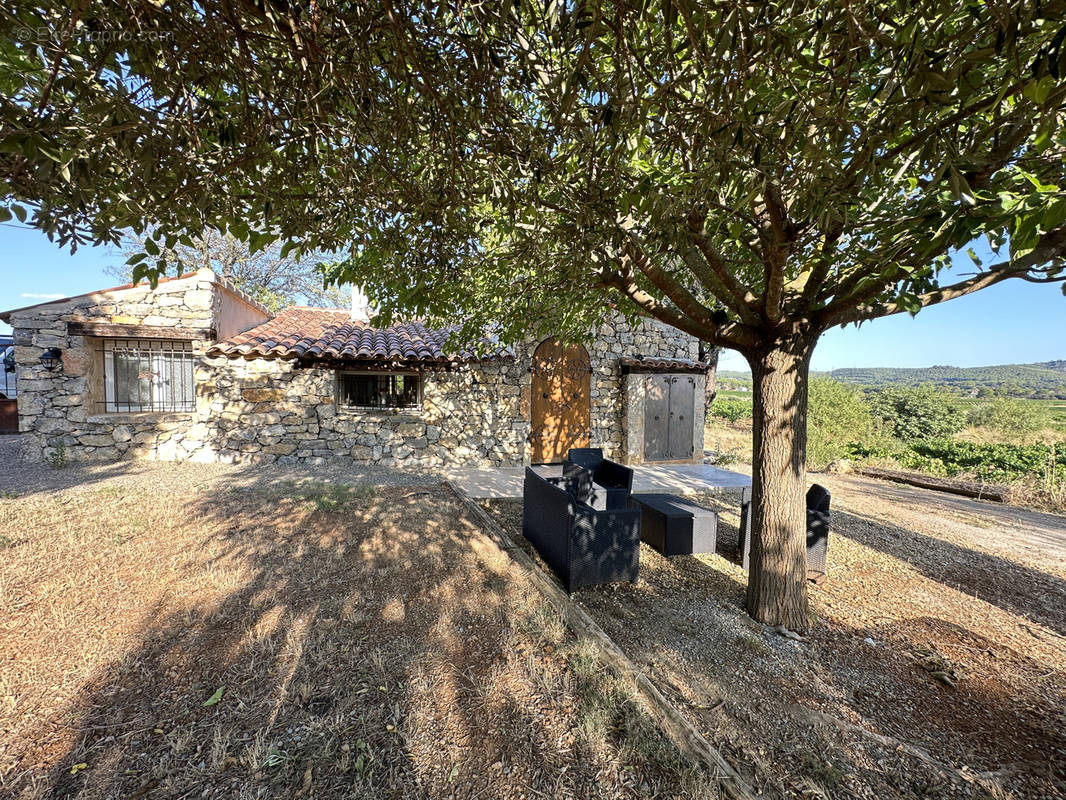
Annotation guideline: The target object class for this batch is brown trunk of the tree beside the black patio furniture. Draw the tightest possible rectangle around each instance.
[747,338,814,630]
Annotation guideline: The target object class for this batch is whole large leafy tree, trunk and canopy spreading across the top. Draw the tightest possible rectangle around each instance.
[6,0,1066,627]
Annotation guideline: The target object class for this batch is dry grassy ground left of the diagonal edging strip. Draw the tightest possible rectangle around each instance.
[0,461,717,800]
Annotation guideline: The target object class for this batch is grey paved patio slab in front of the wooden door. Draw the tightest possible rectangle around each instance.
[445,464,752,499]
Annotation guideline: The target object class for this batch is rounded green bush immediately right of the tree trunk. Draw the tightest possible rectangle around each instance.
[807,378,874,469]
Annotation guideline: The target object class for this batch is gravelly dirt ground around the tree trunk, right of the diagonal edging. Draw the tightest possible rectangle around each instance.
[488,475,1066,800]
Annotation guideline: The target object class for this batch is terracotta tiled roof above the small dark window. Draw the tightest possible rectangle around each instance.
[208,306,513,362]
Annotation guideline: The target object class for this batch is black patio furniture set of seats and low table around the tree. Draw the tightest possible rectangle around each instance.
[522,448,829,592]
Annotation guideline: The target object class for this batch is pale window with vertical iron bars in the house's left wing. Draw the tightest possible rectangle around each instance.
[102,339,196,413]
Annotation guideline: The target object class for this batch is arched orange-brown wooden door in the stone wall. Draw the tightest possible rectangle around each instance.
[530,339,593,464]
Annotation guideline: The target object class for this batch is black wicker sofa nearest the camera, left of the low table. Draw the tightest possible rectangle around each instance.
[522,467,641,592]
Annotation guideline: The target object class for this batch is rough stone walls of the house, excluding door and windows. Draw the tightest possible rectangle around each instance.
[12,285,702,468]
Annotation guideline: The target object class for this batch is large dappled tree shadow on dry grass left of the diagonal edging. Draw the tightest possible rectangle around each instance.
[0,466,712,799]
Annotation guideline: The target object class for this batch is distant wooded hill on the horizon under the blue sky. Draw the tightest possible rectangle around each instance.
[718,359,1066,400]
